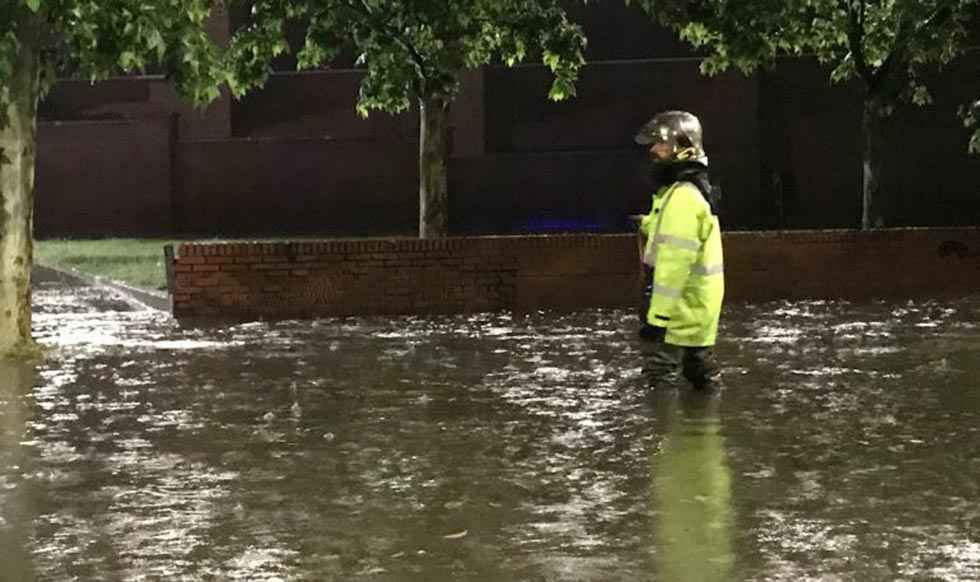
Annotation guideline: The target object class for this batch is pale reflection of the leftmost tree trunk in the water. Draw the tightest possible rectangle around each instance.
[0,359,35,580]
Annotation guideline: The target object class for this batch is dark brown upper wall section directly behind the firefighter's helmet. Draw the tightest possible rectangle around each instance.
[485,61,758,153]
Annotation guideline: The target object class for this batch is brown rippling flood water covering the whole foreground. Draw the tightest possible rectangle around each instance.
[0,284,980,582]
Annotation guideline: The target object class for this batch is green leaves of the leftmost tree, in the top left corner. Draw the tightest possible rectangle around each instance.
[0,0,225,117]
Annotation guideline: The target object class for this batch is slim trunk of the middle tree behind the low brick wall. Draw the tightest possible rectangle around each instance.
[419,97,449,238]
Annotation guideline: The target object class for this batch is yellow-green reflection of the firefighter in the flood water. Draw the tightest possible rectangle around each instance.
[651,391,733,582]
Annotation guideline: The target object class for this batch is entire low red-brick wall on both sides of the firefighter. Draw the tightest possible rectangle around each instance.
[171,228,980,319]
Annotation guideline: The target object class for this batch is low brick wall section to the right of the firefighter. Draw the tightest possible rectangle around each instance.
[725,227,980,301]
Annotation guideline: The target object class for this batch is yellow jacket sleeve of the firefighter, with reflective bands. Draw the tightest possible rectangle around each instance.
[650,185,711,328]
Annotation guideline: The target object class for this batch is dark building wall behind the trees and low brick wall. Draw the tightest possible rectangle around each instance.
[35,3,980,238]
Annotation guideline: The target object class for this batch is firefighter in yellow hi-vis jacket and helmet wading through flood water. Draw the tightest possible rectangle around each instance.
[635,111,725,389]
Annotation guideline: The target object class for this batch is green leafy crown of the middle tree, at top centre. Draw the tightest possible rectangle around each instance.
[231,0,585,115]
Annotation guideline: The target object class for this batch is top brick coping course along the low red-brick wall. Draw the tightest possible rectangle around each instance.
[177,226,980,257]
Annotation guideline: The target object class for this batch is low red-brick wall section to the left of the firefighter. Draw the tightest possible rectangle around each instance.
[172,235,638,318]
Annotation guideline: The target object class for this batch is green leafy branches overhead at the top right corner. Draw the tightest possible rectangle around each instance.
[627,0,978,114]
